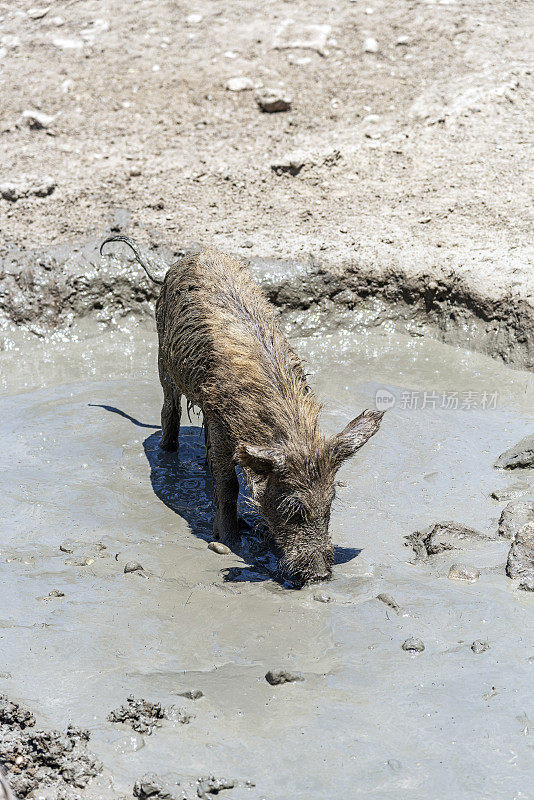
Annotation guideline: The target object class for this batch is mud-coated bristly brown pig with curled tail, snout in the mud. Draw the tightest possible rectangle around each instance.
[102,235,383,585]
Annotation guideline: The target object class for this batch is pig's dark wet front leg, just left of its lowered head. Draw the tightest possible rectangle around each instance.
[204,420,239,547]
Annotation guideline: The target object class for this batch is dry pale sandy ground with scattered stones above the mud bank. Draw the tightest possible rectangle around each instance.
[0,0,534,290]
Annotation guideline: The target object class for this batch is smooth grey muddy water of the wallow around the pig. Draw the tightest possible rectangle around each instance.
[0,322,534,800]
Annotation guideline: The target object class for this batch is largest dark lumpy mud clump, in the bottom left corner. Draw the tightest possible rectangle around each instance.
[0,696,102,800]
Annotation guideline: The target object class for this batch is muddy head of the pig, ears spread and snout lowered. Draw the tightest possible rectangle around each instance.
[236,411,384,586]
